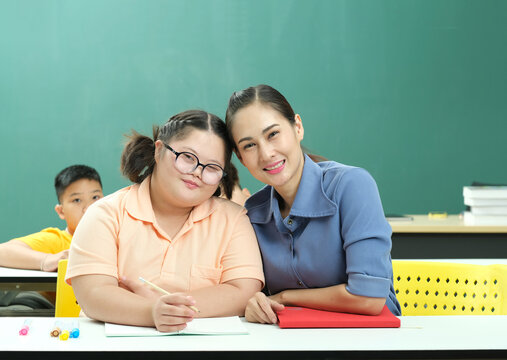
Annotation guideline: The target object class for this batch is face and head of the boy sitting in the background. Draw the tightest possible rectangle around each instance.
[55,179,104,235]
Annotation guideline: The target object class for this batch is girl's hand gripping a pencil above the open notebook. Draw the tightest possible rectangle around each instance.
[152,293,196,332]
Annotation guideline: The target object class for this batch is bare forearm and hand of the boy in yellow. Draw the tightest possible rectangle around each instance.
[0,240,69,271]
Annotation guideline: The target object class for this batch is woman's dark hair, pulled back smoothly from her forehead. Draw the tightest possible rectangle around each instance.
[225,84,327,162]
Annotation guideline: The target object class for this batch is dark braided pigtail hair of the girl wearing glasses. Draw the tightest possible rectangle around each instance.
[121,110,237,199]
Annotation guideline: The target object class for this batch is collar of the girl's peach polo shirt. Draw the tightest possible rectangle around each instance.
[125,175,219,224]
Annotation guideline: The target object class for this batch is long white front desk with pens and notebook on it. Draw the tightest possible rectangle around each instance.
[0,315,507,360]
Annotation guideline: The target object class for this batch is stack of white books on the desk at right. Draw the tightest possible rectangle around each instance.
[463,186,507,225]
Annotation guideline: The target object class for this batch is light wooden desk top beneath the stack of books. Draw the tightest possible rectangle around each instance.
[389,215,507,233]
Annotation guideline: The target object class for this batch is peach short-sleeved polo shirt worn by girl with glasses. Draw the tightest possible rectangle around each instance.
[65,177,264,292]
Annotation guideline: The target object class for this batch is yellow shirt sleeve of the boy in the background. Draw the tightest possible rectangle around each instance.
[13,228,72,254]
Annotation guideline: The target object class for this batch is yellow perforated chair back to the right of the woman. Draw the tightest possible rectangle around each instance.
[393,260,507,315]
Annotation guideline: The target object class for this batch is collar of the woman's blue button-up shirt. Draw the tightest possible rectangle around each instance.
[245,154,338,224]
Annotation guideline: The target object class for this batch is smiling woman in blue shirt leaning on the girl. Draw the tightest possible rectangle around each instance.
[226,85,400,323]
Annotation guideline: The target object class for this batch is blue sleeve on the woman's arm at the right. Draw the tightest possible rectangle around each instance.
[336,168,392,298]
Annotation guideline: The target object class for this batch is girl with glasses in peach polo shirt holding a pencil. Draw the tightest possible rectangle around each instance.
[66,110,264,331]
